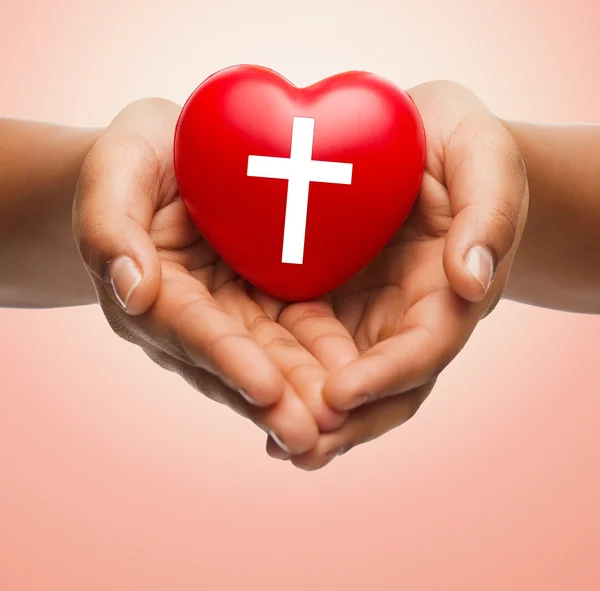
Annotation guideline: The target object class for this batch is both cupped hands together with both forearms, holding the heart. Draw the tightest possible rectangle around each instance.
[5,82,600,469]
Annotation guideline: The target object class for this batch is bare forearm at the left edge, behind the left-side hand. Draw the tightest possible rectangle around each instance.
[0,119,98,308]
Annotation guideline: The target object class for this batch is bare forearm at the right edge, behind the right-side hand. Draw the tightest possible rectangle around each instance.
[505,123,600,313]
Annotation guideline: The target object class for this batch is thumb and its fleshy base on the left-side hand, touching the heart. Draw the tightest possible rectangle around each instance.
[73,101,179,315]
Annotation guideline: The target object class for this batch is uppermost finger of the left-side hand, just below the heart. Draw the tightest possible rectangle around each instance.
[215,281,346,431]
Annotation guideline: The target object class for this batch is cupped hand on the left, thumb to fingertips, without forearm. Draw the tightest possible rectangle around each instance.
[73,99,353,454]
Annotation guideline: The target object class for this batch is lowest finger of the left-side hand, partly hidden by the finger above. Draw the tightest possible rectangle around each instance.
[146,348,319,457]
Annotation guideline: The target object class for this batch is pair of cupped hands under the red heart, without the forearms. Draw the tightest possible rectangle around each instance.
[74,82,527,469]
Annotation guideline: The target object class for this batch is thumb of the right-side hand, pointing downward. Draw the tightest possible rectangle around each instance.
[444,114,528,302]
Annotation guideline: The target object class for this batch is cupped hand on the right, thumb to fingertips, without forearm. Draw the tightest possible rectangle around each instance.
[261,82,529,469]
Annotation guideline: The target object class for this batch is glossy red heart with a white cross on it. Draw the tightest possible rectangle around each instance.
[175,66,425,301]
